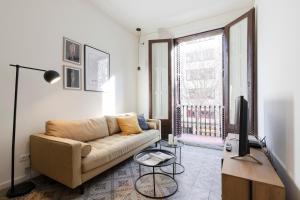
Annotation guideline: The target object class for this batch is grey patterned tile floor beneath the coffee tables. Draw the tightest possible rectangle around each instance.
[0,145,222,200]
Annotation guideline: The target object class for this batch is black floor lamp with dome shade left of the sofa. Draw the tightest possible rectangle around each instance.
[6,65,60,197]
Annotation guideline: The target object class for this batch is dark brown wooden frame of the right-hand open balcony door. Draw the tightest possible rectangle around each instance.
[223,8,257,135]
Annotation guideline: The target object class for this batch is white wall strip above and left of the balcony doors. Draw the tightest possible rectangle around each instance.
[137,7,251,116]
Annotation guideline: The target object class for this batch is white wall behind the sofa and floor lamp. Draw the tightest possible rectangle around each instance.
[0,0,137,188]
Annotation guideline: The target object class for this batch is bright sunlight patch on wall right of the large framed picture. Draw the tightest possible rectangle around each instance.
[102,76,116,115]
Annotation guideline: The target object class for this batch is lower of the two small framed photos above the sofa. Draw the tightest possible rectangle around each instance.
[64,65,81,90]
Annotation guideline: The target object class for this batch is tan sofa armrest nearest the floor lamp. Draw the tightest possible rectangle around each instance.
[30,134,82,188]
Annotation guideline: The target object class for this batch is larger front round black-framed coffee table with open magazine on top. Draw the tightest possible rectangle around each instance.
[133,148,178,199]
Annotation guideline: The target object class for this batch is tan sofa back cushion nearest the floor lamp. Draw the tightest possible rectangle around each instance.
[46,117,109,142]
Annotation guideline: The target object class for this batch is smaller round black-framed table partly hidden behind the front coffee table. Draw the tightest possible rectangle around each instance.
[160,140,185,174]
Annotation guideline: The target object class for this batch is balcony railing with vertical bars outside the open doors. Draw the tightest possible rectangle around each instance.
[177,105,224,138]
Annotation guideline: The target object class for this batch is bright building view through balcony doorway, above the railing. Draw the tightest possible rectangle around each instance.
[177,32,223,105]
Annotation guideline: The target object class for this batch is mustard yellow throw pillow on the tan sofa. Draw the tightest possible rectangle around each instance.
[117,116,142,135]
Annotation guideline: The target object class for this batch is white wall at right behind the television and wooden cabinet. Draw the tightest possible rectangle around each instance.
[255,0,300,200]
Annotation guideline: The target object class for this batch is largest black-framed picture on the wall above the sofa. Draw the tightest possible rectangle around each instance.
[84,45,110,92]
